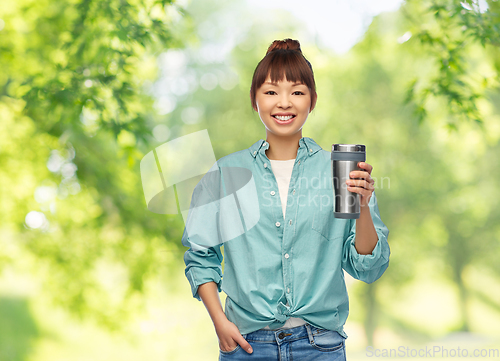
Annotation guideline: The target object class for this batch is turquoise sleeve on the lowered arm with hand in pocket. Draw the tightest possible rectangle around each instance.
[182,170,223,301]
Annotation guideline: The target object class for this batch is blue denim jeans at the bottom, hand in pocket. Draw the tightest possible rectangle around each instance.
[219,323,346,361]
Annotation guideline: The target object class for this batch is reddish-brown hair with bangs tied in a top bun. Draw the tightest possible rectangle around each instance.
[250,39,316,109]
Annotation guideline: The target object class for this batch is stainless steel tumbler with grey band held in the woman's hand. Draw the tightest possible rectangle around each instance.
[331,144,366,219]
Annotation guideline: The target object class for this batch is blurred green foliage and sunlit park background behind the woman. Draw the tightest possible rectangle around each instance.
[0,0,500,360]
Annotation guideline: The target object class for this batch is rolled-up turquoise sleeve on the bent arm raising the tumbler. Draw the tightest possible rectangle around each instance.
[342,192,391,283]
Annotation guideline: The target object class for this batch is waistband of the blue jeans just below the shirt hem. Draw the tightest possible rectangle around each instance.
[242,323,344,345]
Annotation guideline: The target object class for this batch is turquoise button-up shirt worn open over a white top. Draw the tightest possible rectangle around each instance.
[182,137,390,337]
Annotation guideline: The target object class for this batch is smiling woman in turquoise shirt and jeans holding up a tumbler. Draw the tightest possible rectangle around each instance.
[183,39,390,360]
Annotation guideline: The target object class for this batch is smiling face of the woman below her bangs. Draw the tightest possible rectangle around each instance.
[254,75,314,136]
